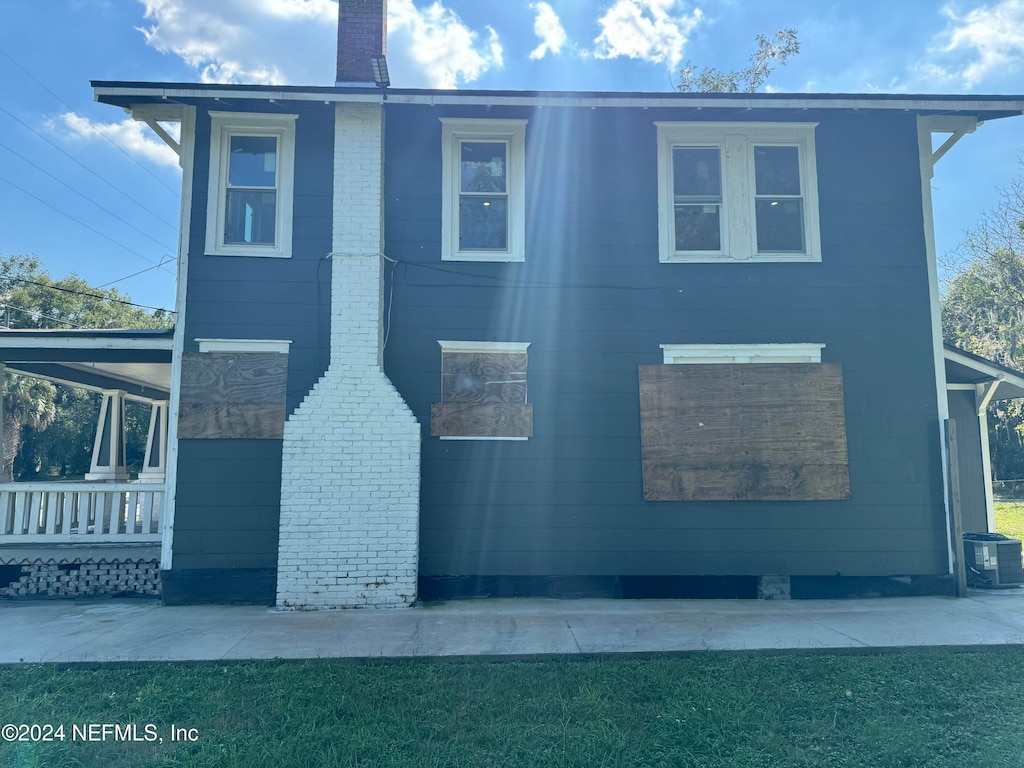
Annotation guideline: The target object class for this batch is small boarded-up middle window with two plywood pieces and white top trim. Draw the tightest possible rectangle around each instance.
[430,341,534,439]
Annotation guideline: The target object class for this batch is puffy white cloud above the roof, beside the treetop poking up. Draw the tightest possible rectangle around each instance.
[594,0,703,69]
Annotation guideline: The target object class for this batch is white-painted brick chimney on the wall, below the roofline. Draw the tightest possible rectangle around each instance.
[278,105,420,608]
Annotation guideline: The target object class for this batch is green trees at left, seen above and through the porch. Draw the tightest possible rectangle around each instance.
[0,256,171,480]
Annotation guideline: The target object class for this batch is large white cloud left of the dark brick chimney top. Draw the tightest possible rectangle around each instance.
[139,0,338,84]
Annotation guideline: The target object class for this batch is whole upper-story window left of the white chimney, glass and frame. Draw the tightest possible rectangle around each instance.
[206,112,297,257]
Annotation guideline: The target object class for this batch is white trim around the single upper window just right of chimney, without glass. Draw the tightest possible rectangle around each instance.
[440,118,527,261]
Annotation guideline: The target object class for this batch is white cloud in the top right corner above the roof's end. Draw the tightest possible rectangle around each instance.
[919,0,1024,88]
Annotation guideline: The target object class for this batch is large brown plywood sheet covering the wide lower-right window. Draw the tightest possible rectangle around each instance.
[640,362,850,501]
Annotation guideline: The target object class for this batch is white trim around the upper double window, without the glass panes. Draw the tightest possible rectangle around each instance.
[654,122,821,263]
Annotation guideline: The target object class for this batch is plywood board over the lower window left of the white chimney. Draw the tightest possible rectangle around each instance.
[178,352,288,440]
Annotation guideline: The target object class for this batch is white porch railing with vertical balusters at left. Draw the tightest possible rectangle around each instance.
[0,482,164,545]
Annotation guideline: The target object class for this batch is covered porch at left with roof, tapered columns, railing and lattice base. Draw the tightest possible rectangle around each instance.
[0,330,173,597]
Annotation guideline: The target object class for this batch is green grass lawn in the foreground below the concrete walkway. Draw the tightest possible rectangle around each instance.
[6,646,1024,768]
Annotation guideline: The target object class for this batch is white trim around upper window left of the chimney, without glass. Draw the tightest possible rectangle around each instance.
[206,112,298,258]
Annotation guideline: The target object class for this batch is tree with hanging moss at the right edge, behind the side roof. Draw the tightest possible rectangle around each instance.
[942,168,1024,493]
